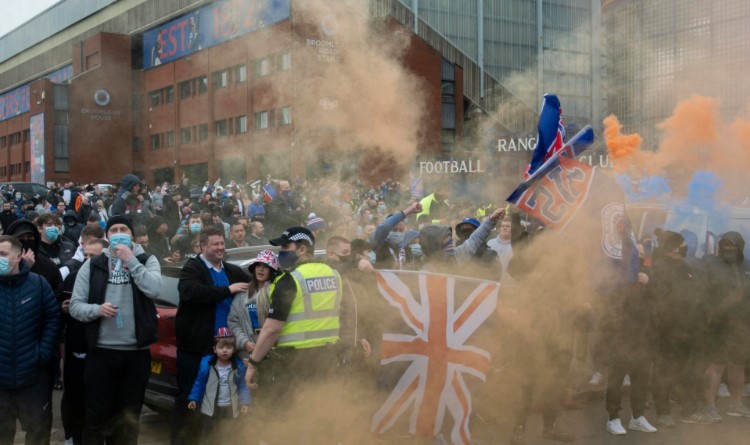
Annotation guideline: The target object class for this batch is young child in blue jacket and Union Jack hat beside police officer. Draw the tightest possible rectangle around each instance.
[188,328,250,443]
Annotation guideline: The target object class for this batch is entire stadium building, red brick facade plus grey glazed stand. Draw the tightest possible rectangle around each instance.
[0,0,602,187]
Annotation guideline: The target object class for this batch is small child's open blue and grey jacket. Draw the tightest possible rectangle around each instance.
[188,354,250,417]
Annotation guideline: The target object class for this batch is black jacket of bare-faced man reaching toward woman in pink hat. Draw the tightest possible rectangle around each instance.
[175,257,249,354]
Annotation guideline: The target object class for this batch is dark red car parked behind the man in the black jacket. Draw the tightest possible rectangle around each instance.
[144,246,325,412]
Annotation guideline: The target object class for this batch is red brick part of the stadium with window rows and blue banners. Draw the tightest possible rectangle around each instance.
[0,0,465,183]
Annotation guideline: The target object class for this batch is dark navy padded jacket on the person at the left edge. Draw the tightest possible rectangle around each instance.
[0,260,60,389]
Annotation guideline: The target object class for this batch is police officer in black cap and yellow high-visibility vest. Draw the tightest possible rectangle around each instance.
[245,227,341,436]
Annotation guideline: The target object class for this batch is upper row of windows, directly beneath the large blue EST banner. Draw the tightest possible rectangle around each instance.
[148,51,292,107]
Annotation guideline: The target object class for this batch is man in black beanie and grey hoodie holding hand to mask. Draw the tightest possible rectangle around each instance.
[69,215,162,444]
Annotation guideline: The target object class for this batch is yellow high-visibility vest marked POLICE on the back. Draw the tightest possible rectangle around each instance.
[270,263,341,349]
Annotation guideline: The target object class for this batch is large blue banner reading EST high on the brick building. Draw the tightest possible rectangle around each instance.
[143,0,290,69]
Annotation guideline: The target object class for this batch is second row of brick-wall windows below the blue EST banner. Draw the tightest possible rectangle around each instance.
[149,107,292,150]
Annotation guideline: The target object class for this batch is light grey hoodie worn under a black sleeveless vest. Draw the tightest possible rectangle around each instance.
[70,244,162,350]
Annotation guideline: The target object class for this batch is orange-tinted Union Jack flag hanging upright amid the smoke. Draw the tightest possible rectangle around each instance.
[371,271,499,444]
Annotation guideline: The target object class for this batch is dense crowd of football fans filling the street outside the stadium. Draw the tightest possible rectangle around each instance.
[0,175,750,444]
